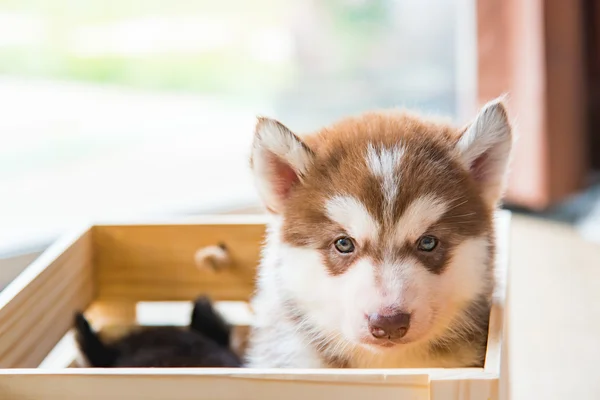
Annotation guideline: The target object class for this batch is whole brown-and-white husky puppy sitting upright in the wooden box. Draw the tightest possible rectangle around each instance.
[249,101,512,367]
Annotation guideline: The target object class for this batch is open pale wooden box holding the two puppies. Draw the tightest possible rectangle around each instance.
[0,212,510,400]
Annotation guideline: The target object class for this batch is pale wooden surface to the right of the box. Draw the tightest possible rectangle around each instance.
[508,216,600,400]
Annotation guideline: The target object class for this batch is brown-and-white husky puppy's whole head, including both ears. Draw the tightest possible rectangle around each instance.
[251,100,512,349]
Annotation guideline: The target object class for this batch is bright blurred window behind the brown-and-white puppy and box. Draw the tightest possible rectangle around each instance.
[0,0,476,253]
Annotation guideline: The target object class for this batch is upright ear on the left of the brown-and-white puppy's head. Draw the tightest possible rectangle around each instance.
[250,118,314,214]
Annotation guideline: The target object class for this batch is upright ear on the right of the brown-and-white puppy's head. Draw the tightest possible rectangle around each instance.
[456,97,513,207]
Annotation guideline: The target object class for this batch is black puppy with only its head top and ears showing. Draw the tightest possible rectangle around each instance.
[75,296,241,368]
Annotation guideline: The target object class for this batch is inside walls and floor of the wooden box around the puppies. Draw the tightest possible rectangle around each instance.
[0,213,508,376]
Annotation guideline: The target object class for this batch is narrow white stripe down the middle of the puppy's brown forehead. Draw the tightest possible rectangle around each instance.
[367,144,404,215]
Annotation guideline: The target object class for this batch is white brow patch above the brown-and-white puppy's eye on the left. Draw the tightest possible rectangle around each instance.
[325,196,379,240]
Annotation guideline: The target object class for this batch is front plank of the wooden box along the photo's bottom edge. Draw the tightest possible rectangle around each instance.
[0,370,429,400]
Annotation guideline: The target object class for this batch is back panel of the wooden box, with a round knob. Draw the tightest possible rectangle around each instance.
[93,216,266,302]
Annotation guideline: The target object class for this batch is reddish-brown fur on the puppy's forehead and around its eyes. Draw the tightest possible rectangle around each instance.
[282,112,492,275]
